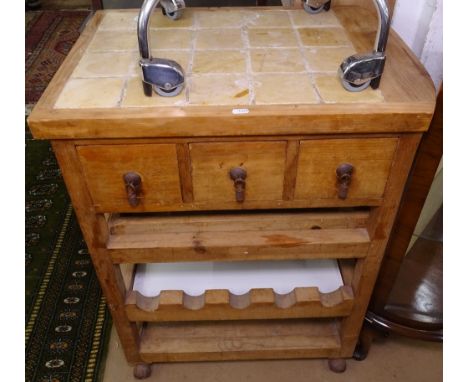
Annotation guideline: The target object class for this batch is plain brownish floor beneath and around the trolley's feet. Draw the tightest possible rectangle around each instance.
[103,330,442,382]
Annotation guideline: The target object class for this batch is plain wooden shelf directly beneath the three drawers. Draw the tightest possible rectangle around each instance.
[107,211,370,263]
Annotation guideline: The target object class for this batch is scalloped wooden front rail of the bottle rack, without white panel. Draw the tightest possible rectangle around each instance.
[125,286,354,322]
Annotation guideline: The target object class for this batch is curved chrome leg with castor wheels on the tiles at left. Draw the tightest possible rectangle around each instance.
[137,0,185,97]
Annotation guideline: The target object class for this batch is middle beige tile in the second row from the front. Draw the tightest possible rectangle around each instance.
[192,50,247,73]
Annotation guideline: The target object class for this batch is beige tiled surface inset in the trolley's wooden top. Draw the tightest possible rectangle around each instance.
[55,8,383,108]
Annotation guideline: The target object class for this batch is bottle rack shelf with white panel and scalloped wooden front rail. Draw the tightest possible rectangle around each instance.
[126,259,354,322]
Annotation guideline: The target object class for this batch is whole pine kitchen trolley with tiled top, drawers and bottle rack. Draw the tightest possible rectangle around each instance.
[29,0,435,377]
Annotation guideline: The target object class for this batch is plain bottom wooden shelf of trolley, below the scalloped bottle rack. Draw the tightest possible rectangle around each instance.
[139,319,341,363]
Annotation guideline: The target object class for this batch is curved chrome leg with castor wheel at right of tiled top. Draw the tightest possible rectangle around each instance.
[338,0,390,92]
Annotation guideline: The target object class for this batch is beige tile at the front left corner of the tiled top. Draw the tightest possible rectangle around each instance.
[55,78,124,109]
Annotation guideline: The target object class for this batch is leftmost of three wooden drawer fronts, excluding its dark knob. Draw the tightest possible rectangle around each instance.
[77,144,182,212]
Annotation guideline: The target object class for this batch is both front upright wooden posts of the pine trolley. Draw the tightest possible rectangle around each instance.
[53,134,421,363]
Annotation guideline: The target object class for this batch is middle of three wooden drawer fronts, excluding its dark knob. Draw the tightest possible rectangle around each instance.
[190,142,286,208]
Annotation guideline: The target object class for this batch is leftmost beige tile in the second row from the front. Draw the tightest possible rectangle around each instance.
[72,52,134,78]
